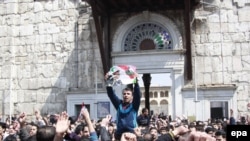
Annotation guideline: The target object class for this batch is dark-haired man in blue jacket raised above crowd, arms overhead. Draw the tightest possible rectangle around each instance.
[105,74,141,140]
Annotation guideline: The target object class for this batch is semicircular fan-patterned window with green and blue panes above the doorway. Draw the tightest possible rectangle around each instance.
[124,23,173,51]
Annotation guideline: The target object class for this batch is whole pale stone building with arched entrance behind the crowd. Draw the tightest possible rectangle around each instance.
[0,0,250,120]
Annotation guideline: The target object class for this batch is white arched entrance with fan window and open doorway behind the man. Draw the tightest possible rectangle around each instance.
[111,12,185,117]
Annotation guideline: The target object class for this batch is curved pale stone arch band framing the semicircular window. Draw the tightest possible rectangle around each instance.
[112,12,183,52]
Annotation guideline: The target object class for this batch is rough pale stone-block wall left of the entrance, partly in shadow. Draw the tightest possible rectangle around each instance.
[0,0,103,118]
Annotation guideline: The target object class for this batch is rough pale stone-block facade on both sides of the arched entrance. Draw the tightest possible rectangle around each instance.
[0,0,250,120]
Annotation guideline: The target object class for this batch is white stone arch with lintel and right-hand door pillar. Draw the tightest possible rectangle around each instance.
[111,12,185,117]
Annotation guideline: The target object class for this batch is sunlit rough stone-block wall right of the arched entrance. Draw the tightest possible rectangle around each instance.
[192,0,250,115]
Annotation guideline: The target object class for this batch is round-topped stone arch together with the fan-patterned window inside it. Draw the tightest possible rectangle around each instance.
[113,12,183,52]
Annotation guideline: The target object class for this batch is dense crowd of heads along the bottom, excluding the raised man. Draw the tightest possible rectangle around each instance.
[0,108,249,141]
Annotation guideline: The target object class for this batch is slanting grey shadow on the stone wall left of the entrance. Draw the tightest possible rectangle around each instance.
[38,0,98,114]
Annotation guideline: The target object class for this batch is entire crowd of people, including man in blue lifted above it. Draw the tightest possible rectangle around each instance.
[0,73,250,141]
